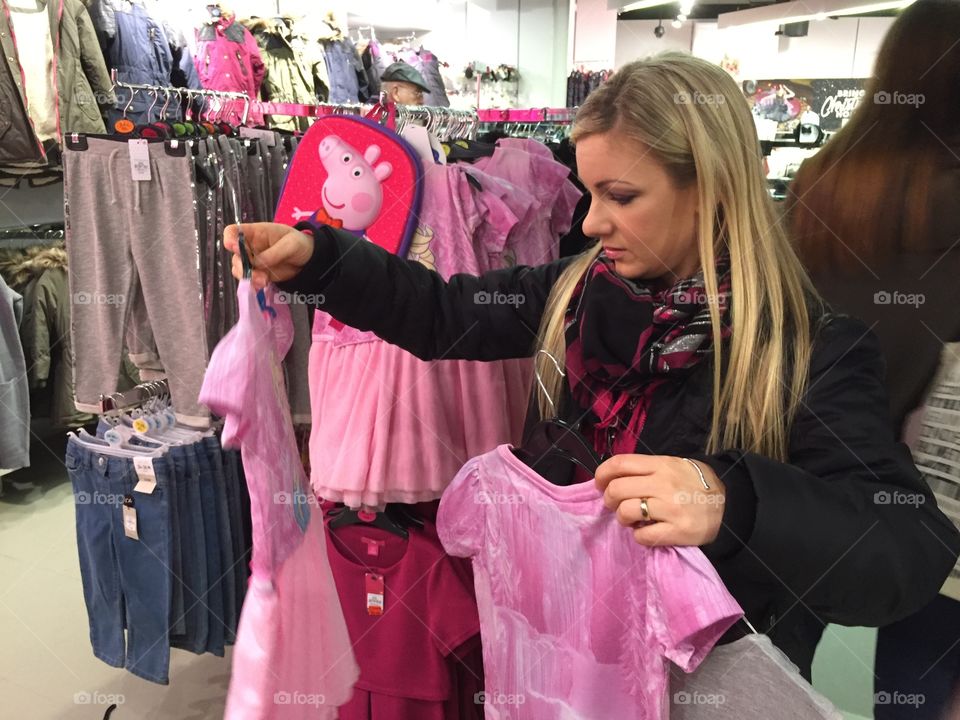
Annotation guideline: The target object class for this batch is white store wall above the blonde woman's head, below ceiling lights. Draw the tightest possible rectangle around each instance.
[616,18,893,79]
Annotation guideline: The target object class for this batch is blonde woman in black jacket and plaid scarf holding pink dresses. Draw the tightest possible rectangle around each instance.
[225,54,960,678]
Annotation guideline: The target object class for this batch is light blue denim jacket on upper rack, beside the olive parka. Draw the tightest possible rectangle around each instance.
[91,0,173,128]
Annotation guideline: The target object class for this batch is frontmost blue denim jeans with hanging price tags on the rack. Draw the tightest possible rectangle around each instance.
[66,439,172,684]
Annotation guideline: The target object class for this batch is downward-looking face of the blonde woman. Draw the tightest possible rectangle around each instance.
[577,131,700,284]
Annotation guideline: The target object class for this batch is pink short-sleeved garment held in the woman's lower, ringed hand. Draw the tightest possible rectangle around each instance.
[437,445,743,720]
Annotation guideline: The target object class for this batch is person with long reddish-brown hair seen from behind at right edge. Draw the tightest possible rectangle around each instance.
[788,0,960,720]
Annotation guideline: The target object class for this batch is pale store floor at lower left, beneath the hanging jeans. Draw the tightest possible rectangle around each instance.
[0,435,230,720]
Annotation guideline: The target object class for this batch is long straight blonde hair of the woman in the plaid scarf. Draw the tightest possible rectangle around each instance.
[536,52,817,460]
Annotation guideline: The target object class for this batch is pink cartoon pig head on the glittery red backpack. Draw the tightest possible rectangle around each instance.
[320,135,393,230]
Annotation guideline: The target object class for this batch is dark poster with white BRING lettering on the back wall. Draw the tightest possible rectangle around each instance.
[742,78,867,140]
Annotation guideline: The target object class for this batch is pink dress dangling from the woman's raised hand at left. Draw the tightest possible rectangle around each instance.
[200,281,359,720]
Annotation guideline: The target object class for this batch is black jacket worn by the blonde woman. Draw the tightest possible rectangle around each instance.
[283,228,960,678]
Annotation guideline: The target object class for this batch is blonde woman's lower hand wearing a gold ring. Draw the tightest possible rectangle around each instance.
[596,454,726,546]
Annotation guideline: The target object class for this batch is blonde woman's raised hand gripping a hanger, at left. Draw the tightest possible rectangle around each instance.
[223,223,314,290]
